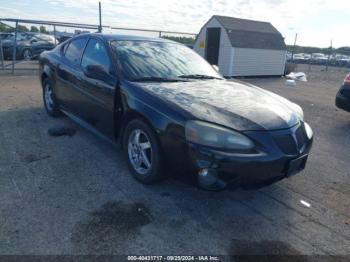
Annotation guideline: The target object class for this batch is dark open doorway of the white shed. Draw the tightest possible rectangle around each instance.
[205,27,221,65]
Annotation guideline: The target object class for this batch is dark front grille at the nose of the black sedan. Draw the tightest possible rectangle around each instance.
[273,125,306,155]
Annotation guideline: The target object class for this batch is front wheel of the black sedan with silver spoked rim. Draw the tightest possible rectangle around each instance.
[123,119,163,184]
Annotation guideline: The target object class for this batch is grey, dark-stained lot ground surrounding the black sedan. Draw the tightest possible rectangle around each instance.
[0,65,350,255]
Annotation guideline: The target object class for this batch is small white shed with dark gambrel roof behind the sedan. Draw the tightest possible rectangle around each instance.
[193,15,287,77]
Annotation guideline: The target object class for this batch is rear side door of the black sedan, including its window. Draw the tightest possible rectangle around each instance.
[55,37,88,117]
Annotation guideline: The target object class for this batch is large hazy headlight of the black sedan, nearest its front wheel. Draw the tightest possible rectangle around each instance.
[186,121,254,150]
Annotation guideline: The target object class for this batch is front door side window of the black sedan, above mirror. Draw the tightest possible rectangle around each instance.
[81,38,111,73]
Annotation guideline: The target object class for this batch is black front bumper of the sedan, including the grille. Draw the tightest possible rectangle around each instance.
[188,123,313,186]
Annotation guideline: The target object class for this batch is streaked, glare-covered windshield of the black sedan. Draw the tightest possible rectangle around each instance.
[111,41,222,81]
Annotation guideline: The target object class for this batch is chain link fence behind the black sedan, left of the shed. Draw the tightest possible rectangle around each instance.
[0,18,196,74]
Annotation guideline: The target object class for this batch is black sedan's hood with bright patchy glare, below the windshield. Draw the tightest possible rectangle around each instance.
[137,80,303,131]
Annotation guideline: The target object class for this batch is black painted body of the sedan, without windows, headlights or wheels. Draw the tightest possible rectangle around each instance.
[40,34,312,188]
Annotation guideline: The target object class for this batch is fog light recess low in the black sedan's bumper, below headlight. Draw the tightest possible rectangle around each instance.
[198,168,226,191]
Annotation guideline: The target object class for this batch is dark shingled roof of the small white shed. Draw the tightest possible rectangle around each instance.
[213,15,286,50]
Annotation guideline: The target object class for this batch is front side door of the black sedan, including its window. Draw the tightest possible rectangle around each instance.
[80,38,117,138]
